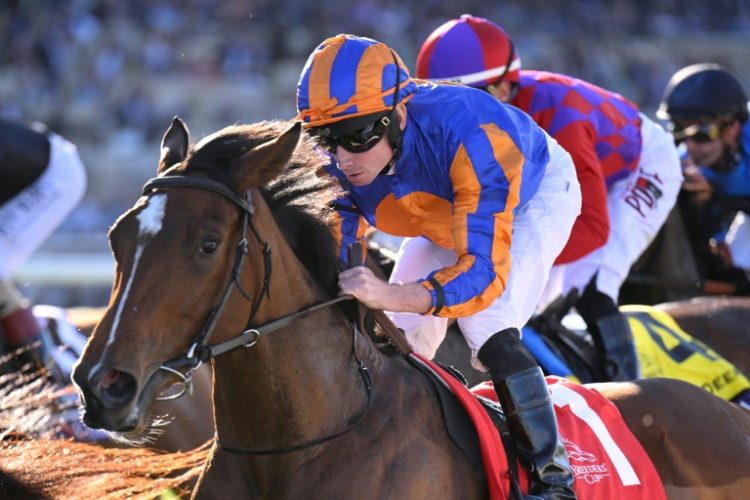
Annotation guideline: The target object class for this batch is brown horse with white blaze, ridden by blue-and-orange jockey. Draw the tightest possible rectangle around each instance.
[73,118,750,499]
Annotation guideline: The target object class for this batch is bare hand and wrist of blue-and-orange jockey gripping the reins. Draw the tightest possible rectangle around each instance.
[339,266,432,313]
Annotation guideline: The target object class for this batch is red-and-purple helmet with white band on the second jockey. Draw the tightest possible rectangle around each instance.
[417,14,521,89]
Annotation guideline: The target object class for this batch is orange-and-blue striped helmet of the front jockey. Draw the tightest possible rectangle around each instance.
[297,35,417,127]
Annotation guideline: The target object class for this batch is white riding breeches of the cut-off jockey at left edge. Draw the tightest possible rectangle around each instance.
[0,134,86,280]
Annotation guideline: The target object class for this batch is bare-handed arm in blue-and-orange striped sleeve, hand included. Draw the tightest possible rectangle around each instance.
[339,125,524,317]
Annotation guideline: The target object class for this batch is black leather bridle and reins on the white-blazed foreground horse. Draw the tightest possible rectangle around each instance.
[143,175,372,455]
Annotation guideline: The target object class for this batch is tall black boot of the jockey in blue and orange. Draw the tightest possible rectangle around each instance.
[477,328,576,499]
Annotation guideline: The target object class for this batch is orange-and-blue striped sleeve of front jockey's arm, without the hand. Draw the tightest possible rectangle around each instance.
[420,124,525,318]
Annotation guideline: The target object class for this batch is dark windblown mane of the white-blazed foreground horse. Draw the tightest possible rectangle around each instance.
[184,121,339,295]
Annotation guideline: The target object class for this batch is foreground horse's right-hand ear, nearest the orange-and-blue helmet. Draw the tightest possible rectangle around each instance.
[238,122,302,191]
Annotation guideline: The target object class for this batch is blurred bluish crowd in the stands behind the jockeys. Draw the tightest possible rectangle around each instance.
[0,0,750,304]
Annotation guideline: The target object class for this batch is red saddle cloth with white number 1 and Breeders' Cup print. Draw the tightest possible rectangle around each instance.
[413,354,666,500]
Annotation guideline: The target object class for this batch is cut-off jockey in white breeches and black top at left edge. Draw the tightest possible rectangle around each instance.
[0,119,86,376]
